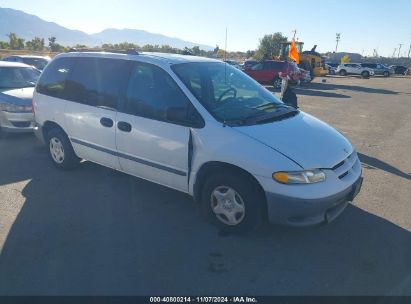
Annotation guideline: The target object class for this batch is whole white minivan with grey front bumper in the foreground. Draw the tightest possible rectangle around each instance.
[33,52,362,231]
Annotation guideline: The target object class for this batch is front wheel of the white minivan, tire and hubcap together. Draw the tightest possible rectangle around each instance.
[201,170,265,233]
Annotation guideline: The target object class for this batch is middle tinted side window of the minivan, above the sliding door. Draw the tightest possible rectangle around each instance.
[65,57,130,110]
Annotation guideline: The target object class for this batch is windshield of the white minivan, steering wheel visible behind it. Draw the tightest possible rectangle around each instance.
[172,62,298,125]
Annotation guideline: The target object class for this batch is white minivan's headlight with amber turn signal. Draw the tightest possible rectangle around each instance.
[273,169,325,184]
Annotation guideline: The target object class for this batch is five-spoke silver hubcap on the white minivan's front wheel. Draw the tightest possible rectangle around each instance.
[211,186,245,226]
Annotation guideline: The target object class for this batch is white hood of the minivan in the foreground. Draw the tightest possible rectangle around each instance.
[234,112,353,169]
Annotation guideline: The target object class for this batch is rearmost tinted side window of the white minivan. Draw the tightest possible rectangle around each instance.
[37,58,73,98]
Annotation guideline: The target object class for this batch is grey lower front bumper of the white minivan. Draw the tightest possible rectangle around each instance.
[266,176,363,227]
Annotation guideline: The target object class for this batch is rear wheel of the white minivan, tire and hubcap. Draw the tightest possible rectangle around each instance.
[47,128,80,170]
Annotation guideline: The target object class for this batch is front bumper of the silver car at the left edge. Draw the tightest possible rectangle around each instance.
[0,111,34,133]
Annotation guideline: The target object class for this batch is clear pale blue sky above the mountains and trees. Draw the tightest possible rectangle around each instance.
[0,0,411,56]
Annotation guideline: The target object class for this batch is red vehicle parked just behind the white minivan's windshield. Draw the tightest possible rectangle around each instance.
[244,60,301,89]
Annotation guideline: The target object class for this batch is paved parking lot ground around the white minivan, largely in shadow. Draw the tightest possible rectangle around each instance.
[0,77,411,295]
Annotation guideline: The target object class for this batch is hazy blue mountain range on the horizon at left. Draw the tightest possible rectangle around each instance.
[0,7,213,51]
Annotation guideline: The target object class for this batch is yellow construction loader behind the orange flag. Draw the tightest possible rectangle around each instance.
[280,41,328,78]
